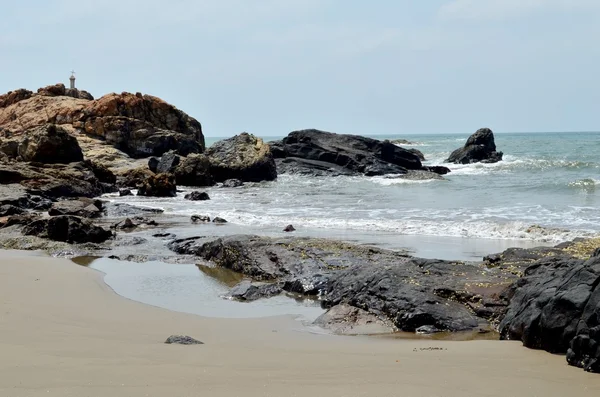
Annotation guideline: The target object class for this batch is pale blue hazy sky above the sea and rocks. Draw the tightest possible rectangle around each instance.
[0,0,600,136]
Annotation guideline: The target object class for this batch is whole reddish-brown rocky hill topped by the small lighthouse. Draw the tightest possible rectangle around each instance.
[0,84,204,157]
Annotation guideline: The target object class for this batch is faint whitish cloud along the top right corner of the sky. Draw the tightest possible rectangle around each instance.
[438,0,600,20]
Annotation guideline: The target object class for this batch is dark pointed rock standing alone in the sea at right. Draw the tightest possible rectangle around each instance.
[446,128,502,164]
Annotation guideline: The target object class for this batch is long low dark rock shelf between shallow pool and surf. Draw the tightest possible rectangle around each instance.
[169,236,517,331]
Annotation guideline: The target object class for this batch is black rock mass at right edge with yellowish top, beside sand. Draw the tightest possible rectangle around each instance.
[486,240,600,372]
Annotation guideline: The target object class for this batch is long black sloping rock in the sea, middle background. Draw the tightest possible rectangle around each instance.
[271,130,448,176]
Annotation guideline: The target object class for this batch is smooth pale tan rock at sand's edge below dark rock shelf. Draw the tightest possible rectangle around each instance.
[314,304,396,335]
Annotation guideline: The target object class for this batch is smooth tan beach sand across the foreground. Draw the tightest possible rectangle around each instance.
[0,251,600,397]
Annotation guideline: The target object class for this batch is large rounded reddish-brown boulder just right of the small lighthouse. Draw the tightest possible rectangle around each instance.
[74,93,204,157]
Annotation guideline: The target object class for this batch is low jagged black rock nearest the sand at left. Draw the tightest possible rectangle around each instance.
[23,215,112,244]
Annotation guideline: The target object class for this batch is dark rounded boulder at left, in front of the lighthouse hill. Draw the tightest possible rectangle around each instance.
[18,124,83,164]
